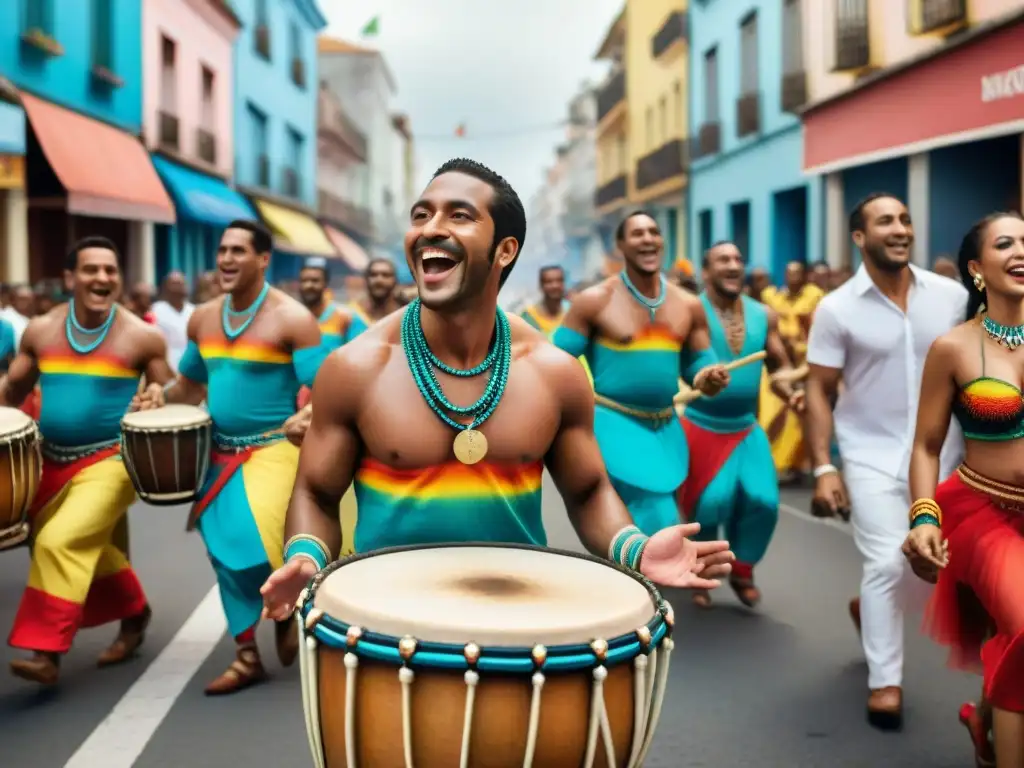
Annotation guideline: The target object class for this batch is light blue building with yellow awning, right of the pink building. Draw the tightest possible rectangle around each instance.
[231,0,337,281]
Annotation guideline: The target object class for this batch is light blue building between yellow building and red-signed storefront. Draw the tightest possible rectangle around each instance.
[689,0,823,281]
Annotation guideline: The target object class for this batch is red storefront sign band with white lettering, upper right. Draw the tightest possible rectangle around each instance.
[803,22,1024,173]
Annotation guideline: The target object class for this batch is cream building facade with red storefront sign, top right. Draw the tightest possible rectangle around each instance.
[803,0,1024,265]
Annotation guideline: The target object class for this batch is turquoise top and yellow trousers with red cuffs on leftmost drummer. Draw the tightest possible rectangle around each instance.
[8,325,146,653]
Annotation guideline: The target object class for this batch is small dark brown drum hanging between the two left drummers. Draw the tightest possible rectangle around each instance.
[121,404,213,506]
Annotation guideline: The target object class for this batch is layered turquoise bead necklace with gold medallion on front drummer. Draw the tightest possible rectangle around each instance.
[401,299,512,464]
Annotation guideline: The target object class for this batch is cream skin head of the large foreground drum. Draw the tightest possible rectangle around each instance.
[313,546,657,647]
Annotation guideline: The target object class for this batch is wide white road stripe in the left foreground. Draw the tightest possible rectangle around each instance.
[65,587,227,768]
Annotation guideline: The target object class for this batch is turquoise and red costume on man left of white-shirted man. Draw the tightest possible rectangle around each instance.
[679,294,779,580]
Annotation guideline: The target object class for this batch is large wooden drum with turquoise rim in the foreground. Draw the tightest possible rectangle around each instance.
[298,544,674,768]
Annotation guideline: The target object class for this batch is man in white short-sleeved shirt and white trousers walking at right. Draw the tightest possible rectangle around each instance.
[807,195,968,729]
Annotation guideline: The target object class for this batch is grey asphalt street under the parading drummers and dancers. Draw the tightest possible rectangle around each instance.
[0,484,980,768]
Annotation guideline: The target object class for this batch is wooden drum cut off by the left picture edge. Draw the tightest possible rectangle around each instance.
[0,407,43,550]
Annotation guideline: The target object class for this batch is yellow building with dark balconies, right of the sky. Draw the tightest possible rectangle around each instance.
[595,0,689,267]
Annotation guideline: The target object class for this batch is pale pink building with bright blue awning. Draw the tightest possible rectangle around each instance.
[142,0,256,286]
